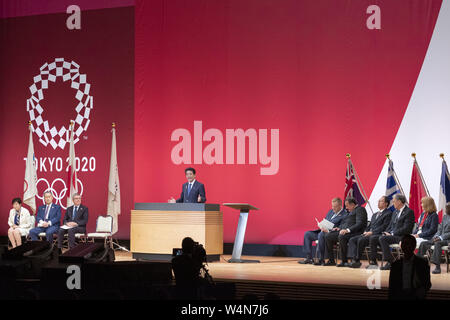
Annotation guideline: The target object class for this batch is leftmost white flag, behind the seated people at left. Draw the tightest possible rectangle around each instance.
[23,126,37,213]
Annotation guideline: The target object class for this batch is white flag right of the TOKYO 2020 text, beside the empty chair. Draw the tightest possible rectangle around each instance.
[107,127,120,234]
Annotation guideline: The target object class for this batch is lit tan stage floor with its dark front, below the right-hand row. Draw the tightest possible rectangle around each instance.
[116,252,450,299]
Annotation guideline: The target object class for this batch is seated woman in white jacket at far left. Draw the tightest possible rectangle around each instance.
[8,198,34,248]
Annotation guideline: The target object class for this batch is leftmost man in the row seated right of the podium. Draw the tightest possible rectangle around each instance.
[298,198,347,265]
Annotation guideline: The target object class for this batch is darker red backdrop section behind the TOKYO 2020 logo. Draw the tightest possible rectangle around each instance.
[0,7,134,238]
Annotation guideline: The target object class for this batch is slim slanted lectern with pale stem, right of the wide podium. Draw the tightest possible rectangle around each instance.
[223,203,259,263]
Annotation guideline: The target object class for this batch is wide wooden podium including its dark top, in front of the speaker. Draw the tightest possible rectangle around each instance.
[130,203,223,261]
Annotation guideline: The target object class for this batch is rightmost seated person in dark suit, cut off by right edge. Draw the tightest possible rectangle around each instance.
[418,202,450,274]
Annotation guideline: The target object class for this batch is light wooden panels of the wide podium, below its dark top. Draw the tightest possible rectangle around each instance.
[130,210,223,254]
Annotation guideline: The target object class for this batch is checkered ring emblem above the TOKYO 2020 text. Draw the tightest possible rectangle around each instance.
[27,58,94,149]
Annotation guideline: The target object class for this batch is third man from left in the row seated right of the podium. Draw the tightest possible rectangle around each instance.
[348,196,392,268]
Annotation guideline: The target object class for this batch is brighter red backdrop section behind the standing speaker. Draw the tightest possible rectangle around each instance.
[135,0,441,244]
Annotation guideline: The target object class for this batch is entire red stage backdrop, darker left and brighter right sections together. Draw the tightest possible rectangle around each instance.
[0,0,441,244]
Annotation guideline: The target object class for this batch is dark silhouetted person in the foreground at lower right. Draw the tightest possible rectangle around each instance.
[389,234,431,300]
